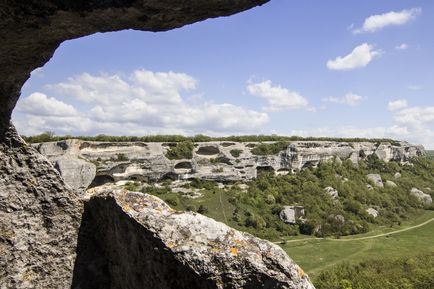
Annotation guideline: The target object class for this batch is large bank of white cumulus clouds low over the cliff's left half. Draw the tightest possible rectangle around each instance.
[14,70,269,135]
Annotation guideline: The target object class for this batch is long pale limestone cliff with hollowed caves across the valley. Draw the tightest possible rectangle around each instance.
[34,140,423,189]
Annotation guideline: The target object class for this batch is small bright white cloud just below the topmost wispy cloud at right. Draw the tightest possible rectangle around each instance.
[327,43,381,70]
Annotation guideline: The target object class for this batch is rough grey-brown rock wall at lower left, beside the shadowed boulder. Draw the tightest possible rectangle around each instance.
[0,127,82,289]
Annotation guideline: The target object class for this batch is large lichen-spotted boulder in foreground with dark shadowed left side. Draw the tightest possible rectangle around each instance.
[73,185,314,289]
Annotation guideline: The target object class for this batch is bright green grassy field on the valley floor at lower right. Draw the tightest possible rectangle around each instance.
[282,211,434,278]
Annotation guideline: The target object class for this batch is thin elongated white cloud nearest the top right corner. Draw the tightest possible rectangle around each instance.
[353,8,422,34]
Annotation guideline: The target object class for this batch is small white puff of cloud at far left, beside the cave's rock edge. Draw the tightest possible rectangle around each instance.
[17,92,77,117]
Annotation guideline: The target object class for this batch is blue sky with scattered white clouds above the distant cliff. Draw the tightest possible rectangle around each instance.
[13,0,434,149]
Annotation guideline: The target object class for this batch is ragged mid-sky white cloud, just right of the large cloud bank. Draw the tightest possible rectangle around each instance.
[247,80,308,111]
